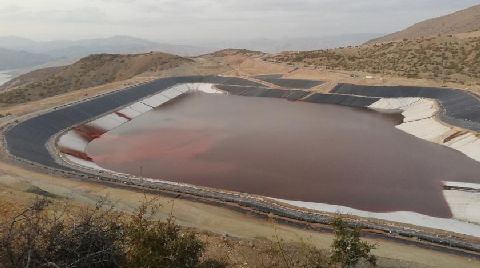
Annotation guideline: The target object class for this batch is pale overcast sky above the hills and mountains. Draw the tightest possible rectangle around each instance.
[0,0,480,42]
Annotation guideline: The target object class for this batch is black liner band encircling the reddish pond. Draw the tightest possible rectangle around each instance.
[5,76,480,253]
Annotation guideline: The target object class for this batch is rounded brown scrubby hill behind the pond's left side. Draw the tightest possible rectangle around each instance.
[0,53,191,105]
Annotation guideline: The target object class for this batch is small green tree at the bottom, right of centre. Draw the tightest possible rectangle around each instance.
[330,217,377,268]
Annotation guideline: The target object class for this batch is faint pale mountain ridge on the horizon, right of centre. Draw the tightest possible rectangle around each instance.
[197,33,382,53]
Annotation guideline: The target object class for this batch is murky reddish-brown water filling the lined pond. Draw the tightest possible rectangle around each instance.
[88,94,480,217]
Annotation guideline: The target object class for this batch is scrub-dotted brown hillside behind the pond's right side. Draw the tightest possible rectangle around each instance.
[266,36,480,85]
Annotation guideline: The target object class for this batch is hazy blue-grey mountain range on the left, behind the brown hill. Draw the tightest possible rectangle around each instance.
[0,36,213,75]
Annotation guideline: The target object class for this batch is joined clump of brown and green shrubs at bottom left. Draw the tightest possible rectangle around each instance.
[0,198,225,268]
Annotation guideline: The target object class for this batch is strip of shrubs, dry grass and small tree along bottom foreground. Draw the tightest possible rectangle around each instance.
[0,196,375,268]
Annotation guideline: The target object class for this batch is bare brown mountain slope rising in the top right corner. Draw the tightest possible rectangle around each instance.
[367,5,480,44]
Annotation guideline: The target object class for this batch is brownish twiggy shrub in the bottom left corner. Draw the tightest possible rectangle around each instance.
[0,199,123,267]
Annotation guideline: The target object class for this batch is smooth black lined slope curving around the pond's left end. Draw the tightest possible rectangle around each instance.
[5,76,261,171]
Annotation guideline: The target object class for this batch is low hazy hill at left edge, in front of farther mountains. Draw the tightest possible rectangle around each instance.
[0,48,53,71]
